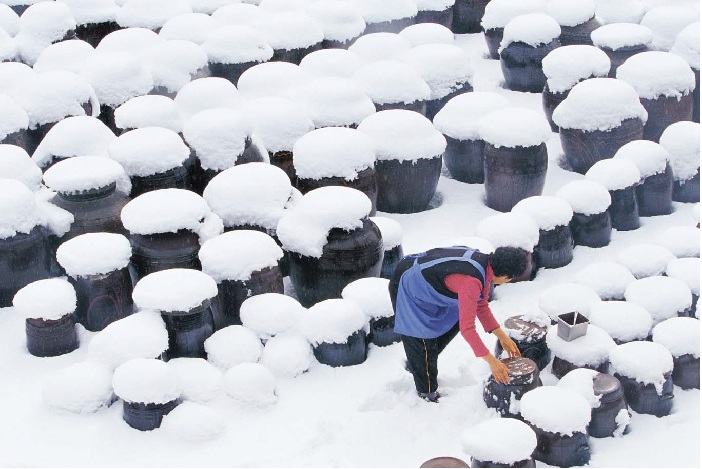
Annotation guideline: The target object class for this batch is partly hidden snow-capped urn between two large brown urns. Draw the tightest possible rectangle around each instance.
[434,91,510,184]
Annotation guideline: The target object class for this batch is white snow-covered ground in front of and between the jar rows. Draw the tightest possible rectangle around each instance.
[0,16,700,467]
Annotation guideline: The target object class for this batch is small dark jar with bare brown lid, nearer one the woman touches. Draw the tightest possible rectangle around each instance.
[483,357,541,418]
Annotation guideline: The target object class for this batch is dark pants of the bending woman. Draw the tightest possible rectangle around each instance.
[402,322,458,393]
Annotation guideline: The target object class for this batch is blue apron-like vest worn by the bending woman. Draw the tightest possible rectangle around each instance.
[395,248,486,339]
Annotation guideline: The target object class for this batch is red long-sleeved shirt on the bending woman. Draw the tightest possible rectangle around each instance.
[444,264,500,357]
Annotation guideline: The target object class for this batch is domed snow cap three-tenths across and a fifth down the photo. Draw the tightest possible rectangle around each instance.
[173,77,243,119]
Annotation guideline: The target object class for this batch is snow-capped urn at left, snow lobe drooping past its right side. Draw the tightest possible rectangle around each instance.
[121,189,224,278]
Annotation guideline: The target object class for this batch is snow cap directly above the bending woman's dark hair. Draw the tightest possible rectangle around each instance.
[474,212,539,252]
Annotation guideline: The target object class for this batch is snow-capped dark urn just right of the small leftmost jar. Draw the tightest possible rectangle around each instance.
[56,233,134,331]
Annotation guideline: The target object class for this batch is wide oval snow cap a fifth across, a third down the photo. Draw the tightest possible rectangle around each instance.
[108,127,190,177]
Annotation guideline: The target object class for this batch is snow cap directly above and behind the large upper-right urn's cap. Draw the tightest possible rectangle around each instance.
[541,44,611,93]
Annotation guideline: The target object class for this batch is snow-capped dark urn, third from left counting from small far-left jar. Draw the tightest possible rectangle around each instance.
[132,268,222,358]
